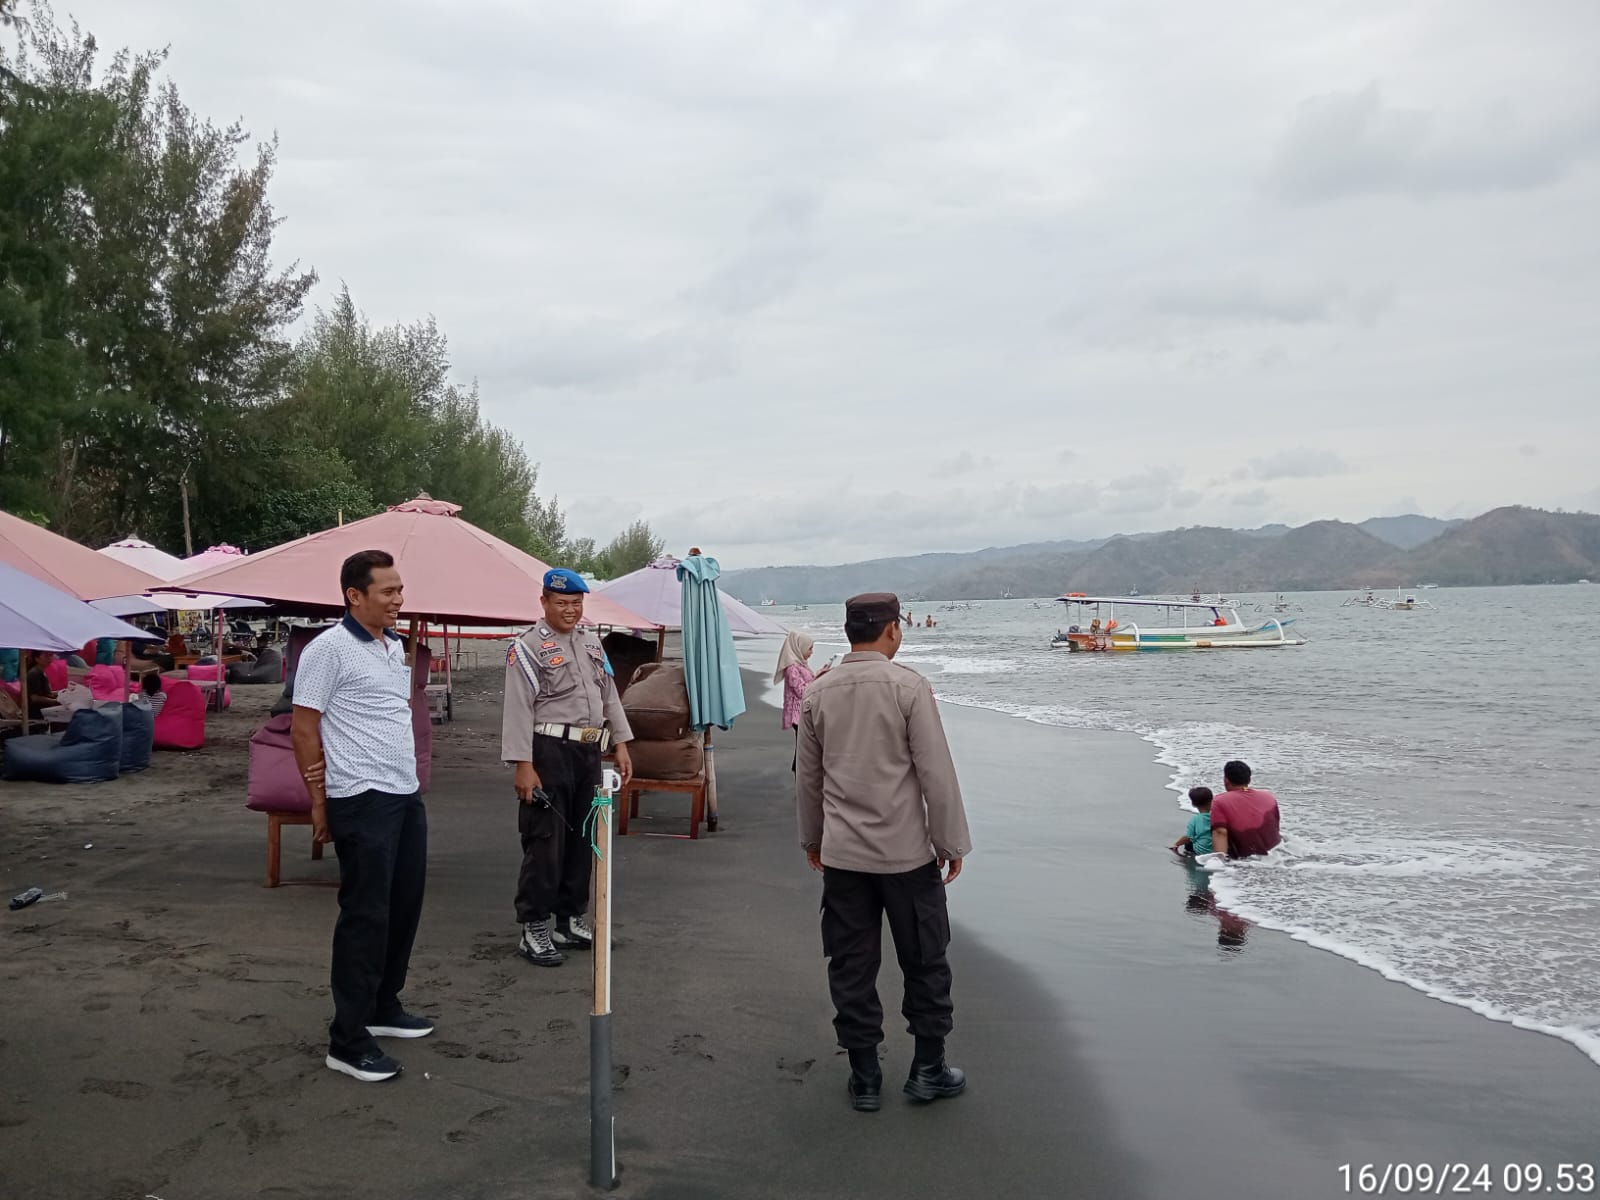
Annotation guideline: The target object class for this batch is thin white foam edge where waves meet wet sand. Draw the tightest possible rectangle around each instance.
[934,691,1600,1066]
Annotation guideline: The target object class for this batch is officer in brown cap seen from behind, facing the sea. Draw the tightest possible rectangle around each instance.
[797,592,973,1112]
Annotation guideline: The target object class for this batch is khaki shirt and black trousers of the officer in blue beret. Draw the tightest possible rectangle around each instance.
[501,621,634,925]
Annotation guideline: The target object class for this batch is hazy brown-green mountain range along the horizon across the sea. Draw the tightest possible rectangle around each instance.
[723,506,1600,603]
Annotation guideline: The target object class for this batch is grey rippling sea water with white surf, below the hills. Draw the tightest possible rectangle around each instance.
[755,586,1600,1062]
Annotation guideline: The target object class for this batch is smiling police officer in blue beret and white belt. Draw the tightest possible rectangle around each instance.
[501,570,634,966]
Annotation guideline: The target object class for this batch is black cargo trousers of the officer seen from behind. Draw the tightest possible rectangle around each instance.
[822,862,955,1050]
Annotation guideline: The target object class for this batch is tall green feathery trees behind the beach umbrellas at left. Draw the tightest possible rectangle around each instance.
[0,9,662,576]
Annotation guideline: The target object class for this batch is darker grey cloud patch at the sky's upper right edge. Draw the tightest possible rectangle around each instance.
[1270,83,1600,203]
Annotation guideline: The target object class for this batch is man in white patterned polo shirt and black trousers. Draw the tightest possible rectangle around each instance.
[293,550,434,1083]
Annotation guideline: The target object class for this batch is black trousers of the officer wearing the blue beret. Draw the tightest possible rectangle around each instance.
[517,733,600,925]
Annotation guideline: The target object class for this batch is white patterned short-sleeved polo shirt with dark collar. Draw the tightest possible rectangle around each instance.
[294,614,418,800]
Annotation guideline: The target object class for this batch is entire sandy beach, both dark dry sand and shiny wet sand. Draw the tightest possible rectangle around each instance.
[0,672,1600,1200]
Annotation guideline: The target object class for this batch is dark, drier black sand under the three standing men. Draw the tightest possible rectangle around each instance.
[0,682,1144,1200]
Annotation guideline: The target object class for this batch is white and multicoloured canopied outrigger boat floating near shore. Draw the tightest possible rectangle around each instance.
[1050,592,1306,651]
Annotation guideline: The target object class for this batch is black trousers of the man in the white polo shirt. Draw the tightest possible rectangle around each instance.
[328,792,427,1058]
